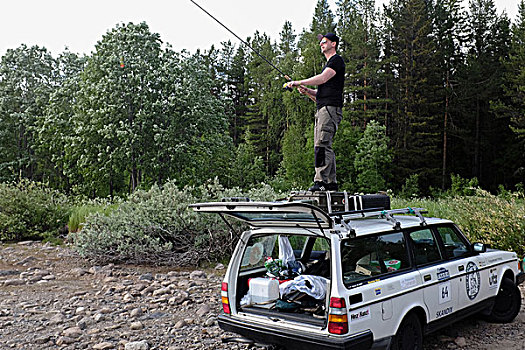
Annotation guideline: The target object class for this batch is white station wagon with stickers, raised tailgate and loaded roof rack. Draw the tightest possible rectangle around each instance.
[192,193,524,350]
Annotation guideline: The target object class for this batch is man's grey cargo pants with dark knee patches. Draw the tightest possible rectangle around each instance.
[314,106,343,184]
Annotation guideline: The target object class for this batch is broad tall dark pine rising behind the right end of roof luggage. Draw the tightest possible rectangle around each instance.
[385,0,441,191]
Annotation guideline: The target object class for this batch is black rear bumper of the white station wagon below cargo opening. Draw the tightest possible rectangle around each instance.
[218,314,373,350]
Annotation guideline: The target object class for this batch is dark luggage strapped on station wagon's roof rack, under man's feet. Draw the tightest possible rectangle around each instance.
[288,191,390,213]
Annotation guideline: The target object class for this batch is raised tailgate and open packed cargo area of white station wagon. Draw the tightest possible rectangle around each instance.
[191,202,333,328]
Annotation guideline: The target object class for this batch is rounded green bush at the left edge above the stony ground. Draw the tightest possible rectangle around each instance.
[0,179,71,241]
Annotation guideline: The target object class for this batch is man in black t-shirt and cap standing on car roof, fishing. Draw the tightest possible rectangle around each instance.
[288,33,345,191]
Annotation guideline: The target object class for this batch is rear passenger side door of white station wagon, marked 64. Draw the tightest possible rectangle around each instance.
[408,227,458,321]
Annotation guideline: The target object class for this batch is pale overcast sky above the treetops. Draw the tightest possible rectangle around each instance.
[0,0,519,56]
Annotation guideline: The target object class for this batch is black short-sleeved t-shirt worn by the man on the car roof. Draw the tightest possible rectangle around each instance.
[315,54,345,109]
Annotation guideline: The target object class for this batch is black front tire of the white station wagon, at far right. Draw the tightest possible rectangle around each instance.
[487,278,521,323]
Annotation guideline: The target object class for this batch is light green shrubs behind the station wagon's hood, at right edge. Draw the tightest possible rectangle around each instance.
[392,189,525,256]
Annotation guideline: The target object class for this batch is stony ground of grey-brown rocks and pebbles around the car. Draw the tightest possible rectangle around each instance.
[0,242,525,350]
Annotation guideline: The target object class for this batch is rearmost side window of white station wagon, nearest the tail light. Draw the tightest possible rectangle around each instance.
[341,232,410,287]
